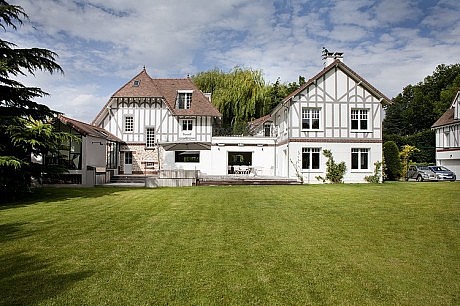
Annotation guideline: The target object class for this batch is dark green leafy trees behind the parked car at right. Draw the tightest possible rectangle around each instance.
[383,64,460,163]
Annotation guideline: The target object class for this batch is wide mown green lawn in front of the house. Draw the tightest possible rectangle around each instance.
[0,183,460,305]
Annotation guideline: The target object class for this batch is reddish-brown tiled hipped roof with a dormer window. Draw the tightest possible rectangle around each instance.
[93,68,222,124]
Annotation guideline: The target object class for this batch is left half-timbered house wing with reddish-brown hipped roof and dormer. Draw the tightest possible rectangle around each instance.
[93,69,221,173]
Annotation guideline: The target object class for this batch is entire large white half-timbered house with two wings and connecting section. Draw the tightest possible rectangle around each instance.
[93,51,389,183]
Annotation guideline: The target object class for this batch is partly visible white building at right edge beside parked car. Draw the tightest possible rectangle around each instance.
[432,91,460,180]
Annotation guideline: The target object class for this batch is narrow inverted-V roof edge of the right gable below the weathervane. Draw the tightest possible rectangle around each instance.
[281,59,391,104]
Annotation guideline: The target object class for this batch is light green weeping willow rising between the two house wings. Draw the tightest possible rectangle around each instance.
[192,67,269,132]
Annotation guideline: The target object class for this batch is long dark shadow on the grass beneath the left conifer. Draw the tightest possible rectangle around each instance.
[0,187,141,210]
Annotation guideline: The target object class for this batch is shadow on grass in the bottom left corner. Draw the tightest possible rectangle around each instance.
[0,252,93,305]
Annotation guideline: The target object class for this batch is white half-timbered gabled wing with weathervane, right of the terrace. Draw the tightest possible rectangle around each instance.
[260,53,390,183]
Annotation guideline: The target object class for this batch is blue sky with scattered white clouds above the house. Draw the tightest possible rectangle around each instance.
[7,0,460,122]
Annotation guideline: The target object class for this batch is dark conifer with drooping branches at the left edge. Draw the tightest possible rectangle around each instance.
[0,0,65,201]
